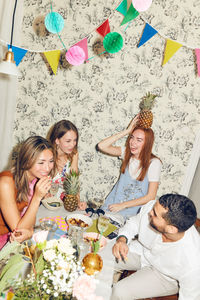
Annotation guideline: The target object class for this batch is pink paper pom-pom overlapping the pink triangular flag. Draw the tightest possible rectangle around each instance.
[65,46,85,66]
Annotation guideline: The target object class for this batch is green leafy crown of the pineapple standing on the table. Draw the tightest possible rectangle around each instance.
[63,170,80,195]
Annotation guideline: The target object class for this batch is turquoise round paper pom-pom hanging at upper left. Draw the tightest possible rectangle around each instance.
[44,12,64,33]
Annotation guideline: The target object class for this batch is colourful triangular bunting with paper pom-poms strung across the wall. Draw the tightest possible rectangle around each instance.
[0,0,200,77]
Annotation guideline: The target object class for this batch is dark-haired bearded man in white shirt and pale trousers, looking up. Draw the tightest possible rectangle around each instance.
[111,194,200,300]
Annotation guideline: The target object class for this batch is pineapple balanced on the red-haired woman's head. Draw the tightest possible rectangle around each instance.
[137,92,157,128]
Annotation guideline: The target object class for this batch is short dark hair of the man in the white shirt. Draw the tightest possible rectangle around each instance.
[159,194,197,232]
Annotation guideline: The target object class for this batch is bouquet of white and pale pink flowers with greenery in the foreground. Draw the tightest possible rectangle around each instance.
[0,237,103,300]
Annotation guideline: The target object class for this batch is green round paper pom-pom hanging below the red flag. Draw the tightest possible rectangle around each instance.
[103,32,123,53]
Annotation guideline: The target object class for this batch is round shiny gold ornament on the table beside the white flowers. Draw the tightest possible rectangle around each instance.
[82,253,103,275]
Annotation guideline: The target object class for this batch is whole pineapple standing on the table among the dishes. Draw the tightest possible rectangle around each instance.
[63,170,80,211]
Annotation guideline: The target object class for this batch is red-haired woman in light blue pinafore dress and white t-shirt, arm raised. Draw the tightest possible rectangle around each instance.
[98,116,161,218]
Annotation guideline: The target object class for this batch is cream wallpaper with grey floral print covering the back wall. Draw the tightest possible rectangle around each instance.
[14,0,200,202]
